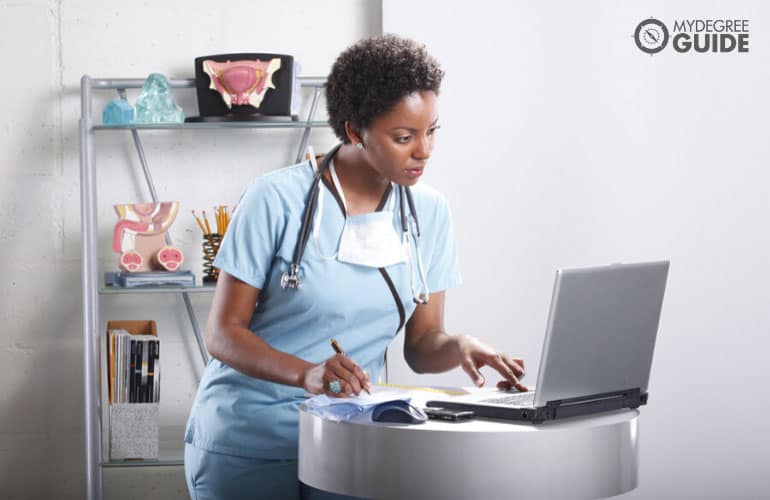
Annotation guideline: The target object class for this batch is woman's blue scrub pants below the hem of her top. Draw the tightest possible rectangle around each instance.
[184,444,355,500]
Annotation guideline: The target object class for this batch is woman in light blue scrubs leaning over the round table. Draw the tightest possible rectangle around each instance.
[185,35,526,498]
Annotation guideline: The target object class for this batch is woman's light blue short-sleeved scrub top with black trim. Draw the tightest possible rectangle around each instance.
[185,162,460,459]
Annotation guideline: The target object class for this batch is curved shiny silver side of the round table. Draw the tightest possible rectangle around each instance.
[299,406,639,500]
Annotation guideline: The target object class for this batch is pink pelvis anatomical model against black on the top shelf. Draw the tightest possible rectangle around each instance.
[203,57,281,109]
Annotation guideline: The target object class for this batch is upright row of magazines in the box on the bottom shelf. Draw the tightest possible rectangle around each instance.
[107,328,160,404]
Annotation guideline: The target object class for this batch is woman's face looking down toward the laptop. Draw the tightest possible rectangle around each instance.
[361,91,438,186]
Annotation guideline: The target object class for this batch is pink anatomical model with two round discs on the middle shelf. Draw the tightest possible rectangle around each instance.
[112,201,184,272]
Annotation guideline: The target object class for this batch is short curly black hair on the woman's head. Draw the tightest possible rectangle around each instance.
[326,34,444,144]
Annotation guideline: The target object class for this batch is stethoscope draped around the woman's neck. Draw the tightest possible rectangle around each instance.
[281,144,430,304]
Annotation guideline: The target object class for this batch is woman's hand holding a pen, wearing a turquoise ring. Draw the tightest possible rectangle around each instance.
[302,354,372,398]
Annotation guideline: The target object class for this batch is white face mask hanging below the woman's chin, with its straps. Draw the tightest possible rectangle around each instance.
[313,162,407,267]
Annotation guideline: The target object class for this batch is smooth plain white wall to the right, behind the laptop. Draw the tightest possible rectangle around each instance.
[383,0,770,500]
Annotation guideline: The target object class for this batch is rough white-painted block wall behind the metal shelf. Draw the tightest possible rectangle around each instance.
[0,0,381,499]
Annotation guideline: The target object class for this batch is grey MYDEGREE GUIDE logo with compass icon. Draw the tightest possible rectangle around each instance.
[633,17,749,55]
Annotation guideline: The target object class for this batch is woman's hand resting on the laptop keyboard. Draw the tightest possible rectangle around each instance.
[457,335,527,392]
